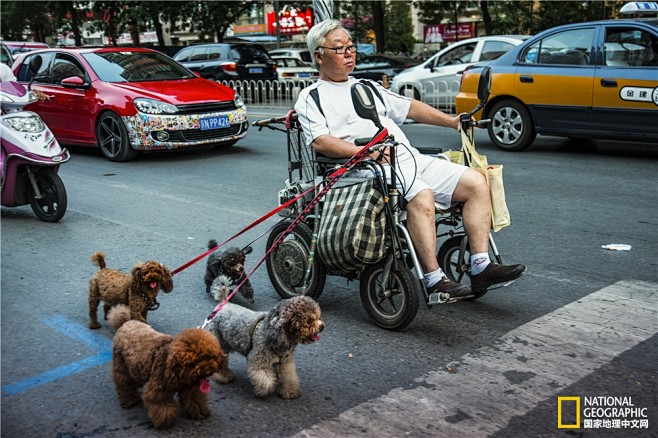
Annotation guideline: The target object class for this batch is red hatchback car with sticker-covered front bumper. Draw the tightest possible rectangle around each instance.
[12,47,249,161]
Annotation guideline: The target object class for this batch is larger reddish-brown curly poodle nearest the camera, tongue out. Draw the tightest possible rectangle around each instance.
[109,305,226,429]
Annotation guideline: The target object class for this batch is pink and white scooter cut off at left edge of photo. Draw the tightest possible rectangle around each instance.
[0,57,71,222]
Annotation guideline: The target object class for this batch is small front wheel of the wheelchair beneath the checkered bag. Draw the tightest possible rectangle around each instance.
[360,260,418,330]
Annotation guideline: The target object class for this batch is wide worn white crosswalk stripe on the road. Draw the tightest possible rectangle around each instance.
[294,281,658,438]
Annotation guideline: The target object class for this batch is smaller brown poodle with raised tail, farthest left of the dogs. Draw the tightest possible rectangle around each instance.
[89,251,174,329]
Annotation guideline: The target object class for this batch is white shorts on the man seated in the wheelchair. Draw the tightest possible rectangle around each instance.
[385,154,468,210]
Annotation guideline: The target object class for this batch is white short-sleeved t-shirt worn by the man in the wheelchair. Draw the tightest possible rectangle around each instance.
[295,76,418,162]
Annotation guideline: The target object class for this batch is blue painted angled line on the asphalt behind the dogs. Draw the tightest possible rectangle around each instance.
[2,315,112,396]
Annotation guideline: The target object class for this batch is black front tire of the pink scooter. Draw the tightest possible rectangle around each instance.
[28,169,68,222]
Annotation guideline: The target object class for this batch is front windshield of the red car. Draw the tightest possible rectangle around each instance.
[82,50,196,82]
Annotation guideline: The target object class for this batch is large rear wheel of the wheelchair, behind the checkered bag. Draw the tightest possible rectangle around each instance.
[265,219,327,300]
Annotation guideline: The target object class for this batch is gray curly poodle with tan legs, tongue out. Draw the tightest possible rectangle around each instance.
[202,296,324,399]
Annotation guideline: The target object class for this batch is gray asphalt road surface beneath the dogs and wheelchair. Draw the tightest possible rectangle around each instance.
[1,108,658,438]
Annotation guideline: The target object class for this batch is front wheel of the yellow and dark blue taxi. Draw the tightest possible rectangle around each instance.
[487,100,537,151]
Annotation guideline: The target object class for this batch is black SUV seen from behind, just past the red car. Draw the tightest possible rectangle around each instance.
[174,43,277,81]
